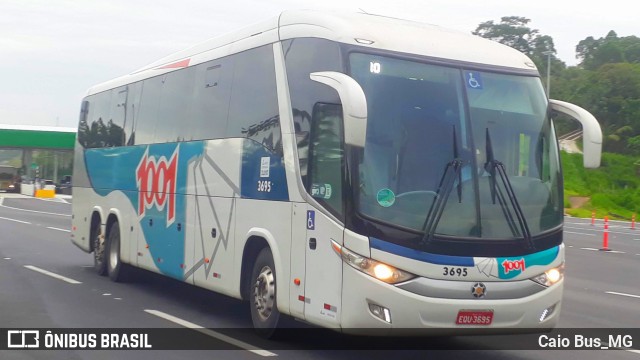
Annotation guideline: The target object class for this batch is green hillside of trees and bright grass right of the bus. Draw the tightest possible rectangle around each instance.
[473,16,640,219]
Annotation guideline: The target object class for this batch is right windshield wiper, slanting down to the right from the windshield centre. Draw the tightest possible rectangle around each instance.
[484,128,535,249]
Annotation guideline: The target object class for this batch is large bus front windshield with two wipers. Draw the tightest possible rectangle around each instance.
[349,53,562,241]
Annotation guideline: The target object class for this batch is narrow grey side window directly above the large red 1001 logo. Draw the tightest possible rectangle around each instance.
[134,76,164,145]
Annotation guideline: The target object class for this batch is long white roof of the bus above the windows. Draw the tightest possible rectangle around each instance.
[87,10,537,95]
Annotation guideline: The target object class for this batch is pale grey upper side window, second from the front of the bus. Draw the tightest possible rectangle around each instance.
[188,58,233,140]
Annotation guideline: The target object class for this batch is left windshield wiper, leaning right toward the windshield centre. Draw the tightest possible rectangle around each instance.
[420,125,463,246]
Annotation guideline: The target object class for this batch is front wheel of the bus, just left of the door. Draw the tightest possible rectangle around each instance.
[249,248,280,338]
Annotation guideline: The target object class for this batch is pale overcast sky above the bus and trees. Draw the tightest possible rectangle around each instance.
[0,0,640,127]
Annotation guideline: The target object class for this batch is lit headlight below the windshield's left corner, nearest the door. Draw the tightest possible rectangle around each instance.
[331,240,416,284]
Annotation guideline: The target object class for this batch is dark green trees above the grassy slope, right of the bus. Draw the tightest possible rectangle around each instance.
[473,16,640,156]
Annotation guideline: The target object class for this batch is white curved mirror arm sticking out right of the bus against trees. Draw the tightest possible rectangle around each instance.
[549,99,602,169]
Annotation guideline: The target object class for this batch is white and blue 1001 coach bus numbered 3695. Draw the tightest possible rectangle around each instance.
[71,11,602,334]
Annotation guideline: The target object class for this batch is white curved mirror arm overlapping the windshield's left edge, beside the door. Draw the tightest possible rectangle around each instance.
[309,71,367,148]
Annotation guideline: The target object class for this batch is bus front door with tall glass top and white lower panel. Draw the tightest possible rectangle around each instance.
[304,103,344,327]
